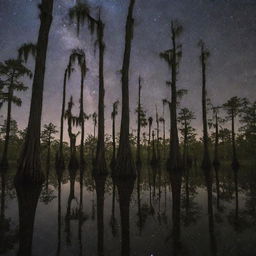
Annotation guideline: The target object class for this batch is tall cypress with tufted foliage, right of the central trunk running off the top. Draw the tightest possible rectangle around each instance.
[160,21,183,170]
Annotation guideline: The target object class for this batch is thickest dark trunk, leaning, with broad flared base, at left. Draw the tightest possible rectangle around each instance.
[16,0,54,183]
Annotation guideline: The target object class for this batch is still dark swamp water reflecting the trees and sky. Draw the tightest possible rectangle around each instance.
[0,168,256,256]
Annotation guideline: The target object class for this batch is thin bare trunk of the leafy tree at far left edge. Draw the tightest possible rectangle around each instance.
[1,74,14,170]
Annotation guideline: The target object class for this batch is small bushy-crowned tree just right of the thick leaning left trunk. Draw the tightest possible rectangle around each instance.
[41,123,58,173]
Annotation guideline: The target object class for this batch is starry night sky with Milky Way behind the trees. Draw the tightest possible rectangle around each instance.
[0,0,256,139]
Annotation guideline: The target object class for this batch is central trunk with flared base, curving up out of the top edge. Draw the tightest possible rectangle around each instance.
[114,0,136,177]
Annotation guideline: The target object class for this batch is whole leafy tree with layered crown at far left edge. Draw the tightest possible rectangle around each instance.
[0,59,32,169]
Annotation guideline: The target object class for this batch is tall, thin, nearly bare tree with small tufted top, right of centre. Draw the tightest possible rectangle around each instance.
[198,40,211,170]
